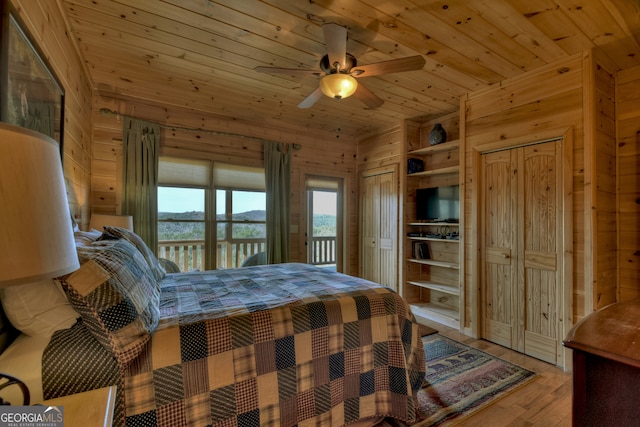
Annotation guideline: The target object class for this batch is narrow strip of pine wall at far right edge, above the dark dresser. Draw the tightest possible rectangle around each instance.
[616,67,640,301]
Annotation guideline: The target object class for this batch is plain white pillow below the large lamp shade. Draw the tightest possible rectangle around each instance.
[0,279,80,337]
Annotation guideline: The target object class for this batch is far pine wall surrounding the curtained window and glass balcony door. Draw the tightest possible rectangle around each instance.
[91,97,358,274]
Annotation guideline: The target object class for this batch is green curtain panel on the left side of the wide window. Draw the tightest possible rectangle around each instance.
[122,117,160,253]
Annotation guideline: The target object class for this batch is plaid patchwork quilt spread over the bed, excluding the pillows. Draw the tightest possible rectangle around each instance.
[47,264,425,427]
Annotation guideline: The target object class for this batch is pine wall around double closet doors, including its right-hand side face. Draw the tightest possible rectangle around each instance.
[462,52,615,330]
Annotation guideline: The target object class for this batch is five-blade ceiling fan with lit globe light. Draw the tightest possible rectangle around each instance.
[255,23,426,108]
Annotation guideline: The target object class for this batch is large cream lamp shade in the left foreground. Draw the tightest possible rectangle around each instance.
[0,123,80,287]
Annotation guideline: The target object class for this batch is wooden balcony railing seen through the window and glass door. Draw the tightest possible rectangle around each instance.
[158,236,336,271]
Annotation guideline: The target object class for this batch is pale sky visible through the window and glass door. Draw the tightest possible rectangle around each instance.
[158,187,337,215]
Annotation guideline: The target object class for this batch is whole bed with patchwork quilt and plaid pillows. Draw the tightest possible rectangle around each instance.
[0,227,425,427]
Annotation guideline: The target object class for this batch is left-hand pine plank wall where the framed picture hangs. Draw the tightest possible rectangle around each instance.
[10,0,92,223]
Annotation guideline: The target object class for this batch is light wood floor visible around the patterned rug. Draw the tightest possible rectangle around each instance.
[424,322,571,427]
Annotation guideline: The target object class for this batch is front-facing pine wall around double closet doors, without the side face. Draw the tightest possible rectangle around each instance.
[461,54,592,330]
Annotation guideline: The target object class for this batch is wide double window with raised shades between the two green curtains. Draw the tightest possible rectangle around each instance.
[158,157,266,271]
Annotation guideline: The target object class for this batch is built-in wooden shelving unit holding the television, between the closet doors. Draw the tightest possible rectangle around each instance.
[403,113,463,330]
